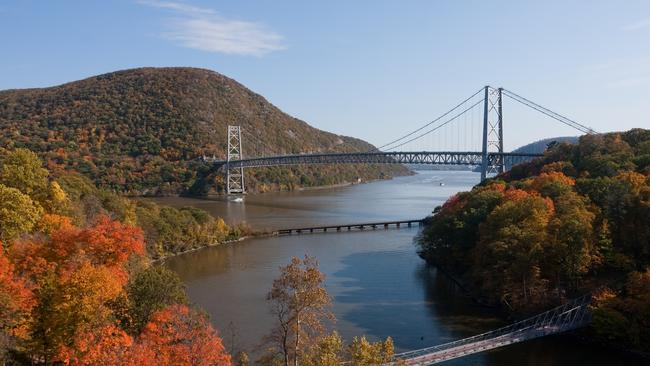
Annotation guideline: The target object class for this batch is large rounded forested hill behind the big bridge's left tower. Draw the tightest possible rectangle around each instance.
[0,68,405,194]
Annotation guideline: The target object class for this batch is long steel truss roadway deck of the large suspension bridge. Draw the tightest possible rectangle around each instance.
[204,151,543,168]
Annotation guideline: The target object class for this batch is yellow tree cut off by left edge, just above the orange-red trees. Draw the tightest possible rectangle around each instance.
[0,184,43,246]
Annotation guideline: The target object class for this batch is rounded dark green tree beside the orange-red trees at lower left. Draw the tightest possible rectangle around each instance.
[126,266,189,334]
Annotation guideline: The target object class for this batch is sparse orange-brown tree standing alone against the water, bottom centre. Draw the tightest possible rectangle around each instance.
[267,256,335,366]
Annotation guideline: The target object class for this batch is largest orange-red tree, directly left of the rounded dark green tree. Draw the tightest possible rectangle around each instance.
[12,214,144,362]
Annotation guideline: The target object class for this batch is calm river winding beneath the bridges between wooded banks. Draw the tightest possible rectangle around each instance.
[155,171,635,366]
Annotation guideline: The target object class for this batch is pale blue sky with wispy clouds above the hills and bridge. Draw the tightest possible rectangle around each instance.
[0,0,650,150]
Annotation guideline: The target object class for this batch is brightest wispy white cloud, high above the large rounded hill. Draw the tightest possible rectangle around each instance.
[138,0,285,56]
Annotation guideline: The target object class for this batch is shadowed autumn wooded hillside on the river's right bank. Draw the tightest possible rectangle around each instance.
[419,129,650,354]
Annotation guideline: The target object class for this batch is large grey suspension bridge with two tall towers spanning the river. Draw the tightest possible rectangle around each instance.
[209,86,596,195]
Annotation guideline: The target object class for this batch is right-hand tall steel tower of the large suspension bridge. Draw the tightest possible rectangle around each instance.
[481,86,506,181]
